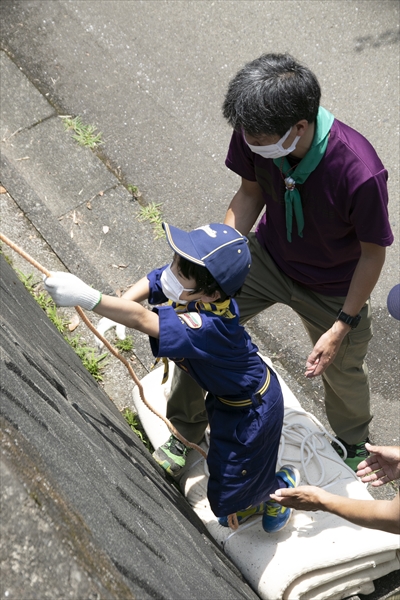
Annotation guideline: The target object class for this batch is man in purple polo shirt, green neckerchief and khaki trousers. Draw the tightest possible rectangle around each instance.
[155,54,393,469]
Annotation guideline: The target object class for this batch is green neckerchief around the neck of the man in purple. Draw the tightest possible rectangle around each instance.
[274,106,335,242]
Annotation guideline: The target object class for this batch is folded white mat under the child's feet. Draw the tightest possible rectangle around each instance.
[133,358,400,600]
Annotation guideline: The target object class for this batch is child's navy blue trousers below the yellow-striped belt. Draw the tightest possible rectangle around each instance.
[206,371,283,517]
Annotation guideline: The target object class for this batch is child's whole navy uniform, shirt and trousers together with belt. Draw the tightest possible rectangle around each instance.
[147,267,283,517]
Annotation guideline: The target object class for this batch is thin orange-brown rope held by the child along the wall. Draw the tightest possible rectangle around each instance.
[0,233,207,458]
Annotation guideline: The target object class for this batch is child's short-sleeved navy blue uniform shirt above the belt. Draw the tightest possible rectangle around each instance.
[147,267,266,401]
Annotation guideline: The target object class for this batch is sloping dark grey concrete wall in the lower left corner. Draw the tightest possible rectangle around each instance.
[0,257,258,600]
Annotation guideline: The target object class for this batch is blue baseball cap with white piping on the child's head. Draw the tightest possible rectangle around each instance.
[163,223,251,296]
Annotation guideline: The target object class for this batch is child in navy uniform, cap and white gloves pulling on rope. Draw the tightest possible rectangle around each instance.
[45,223,299,532]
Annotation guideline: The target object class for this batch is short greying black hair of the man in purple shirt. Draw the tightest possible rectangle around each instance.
[222,54,321,137]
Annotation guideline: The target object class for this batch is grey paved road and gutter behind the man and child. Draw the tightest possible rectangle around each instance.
[0,0,400,599]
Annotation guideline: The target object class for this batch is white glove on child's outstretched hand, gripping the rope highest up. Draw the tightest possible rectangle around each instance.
[43,271,101,310]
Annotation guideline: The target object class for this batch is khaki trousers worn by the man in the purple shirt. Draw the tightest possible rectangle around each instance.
[167,233,372,444]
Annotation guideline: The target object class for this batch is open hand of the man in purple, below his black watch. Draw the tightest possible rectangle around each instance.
[305,321,350,377]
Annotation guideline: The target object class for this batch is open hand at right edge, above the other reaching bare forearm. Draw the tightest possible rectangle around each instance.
[357,444,400,487]
